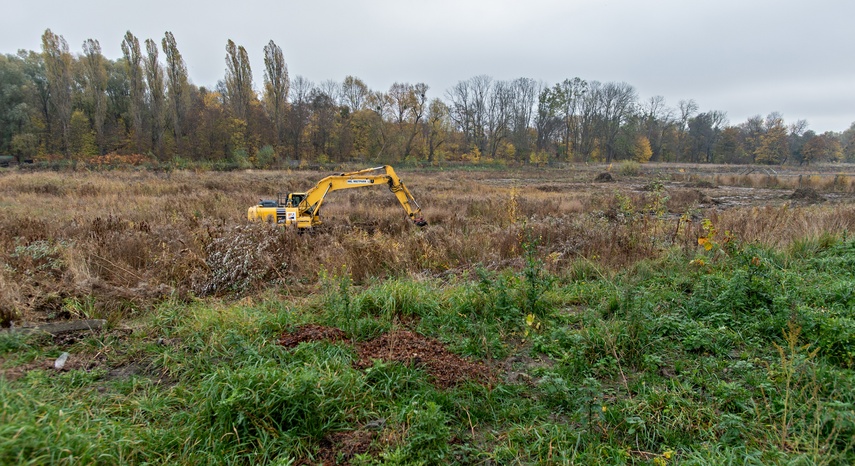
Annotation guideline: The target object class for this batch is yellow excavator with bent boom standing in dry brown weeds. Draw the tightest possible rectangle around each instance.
[246,165,427,229]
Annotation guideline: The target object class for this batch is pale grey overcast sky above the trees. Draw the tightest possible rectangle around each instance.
[0,0,855,133]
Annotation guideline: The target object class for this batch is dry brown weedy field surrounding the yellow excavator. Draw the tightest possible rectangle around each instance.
[0,165,855,325]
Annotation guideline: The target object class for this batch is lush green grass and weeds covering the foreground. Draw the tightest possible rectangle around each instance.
[0,237,855,465]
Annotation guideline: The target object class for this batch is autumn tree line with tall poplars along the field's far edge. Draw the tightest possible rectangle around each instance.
[0,29,855,167]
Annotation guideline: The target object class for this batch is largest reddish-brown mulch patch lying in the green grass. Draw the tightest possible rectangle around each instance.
[356,330,490,388]
